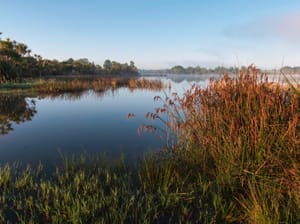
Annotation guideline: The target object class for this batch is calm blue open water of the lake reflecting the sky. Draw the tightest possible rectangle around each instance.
[0,77,218,167]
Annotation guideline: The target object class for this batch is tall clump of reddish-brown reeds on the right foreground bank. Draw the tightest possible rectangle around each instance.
[148,67,300,223]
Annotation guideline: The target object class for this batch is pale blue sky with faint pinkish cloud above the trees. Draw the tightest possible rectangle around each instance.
[0,0,300,69]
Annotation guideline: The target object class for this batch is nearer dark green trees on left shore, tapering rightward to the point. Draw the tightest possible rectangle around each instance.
[0,33,138,83]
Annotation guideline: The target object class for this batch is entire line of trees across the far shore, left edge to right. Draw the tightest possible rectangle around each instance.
[0,32,300,83]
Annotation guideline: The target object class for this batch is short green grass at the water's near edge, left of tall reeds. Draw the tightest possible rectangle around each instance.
[0,156,223,223]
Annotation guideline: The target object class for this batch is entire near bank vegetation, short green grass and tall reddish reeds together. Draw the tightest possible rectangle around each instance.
[0,67,300,223]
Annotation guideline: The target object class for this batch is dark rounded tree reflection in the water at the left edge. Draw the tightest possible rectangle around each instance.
[0,95,37,135]
